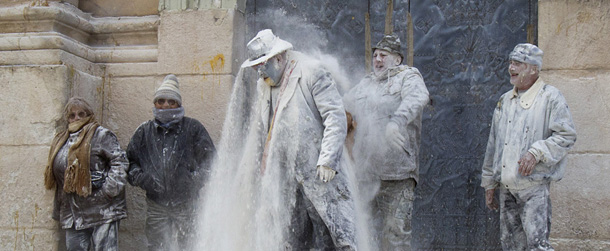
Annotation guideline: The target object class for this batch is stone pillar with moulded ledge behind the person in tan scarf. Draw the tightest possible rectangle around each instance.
[0,1,158,250]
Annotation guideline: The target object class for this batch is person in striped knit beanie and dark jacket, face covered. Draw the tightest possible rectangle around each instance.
[127,74,216,251]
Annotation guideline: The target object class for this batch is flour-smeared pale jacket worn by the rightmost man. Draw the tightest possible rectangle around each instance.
[481,78,576,190]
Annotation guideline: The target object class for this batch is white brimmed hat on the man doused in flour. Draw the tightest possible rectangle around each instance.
[241,29,292,68]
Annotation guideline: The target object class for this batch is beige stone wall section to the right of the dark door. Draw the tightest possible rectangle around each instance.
[538,0,610,250]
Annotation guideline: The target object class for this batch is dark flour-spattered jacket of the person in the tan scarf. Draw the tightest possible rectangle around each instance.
[53,126,128,230]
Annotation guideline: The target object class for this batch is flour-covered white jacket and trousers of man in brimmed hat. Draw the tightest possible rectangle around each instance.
[255,51,355,248]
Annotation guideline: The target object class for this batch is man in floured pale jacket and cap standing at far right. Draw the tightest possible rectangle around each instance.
[481,43,576,250]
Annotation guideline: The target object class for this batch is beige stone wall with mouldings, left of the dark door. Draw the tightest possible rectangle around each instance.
[0,0,245,250]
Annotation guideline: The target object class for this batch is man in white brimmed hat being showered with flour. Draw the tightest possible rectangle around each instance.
[241,29,356,250]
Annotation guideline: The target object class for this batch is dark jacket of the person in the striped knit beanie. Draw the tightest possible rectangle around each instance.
[127,117,216,206]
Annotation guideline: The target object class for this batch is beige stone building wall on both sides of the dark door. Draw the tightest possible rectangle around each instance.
[0,0,610,250]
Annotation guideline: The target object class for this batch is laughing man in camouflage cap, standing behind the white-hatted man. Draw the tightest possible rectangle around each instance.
[343,35,429,250]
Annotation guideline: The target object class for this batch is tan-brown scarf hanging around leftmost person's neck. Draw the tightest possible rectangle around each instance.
[44,116,99,197]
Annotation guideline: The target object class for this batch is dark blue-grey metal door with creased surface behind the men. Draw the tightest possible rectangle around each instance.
[247,0,537,250]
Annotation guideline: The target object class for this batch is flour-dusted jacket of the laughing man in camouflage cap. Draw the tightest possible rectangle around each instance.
[343,65,429,182]
